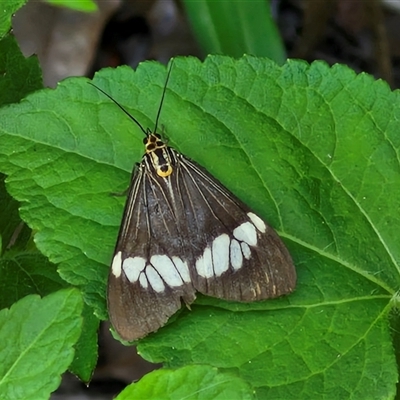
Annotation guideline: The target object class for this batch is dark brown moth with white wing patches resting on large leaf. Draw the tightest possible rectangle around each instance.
[93,63,296,341]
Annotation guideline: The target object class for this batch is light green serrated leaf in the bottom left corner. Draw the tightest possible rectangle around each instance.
[0,289,82,400]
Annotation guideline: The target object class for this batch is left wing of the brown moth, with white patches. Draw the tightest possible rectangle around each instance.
[107,162,196,341]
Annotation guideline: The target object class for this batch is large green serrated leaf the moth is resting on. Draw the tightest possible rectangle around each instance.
[0,57,400,399]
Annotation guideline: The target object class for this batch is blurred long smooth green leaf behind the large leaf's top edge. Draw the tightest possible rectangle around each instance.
[183,0,286,64]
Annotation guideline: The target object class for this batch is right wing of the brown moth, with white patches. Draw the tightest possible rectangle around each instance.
[175,154,296,302]
